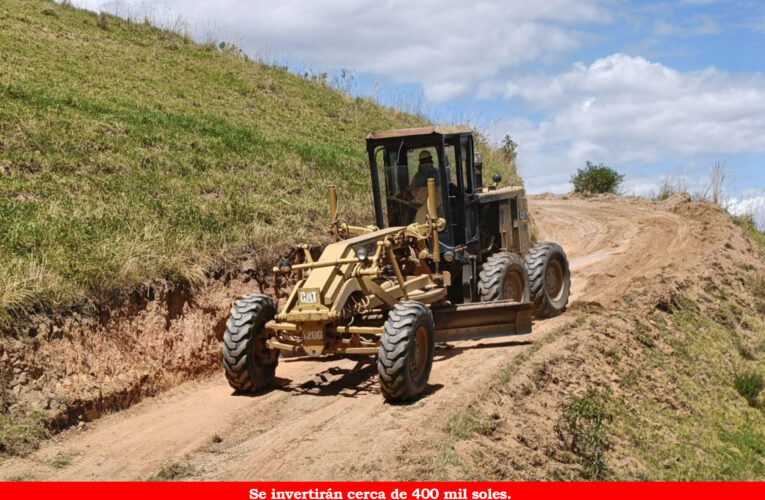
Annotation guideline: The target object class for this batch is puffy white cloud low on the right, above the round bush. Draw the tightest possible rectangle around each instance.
[482,54,765,190]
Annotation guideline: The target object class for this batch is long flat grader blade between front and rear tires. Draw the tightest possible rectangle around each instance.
[432,300,532,342]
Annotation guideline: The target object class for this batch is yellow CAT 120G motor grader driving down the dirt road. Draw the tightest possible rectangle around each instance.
[223,126,570,402]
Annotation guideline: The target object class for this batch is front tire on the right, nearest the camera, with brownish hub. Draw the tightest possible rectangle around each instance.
[377,301,435,403]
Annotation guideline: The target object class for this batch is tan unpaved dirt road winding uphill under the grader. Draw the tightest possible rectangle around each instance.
[0,199,706,480]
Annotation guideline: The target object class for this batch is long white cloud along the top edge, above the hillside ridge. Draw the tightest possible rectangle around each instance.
[75,0,611,102]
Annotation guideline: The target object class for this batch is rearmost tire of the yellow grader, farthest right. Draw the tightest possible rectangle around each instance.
[526,242,571,318]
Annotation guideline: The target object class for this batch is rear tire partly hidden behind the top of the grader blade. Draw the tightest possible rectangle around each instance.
[478,252,530,302]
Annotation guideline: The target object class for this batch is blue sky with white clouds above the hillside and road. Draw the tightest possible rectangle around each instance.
[67,0,765,228]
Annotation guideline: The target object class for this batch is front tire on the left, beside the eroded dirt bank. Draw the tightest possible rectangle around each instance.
[223,293,279,392]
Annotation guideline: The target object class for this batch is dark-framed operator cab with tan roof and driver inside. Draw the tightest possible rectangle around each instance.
[367,126,481,251]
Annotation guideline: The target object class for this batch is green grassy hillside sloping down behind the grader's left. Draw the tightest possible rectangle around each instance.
[0,0,520,323]
